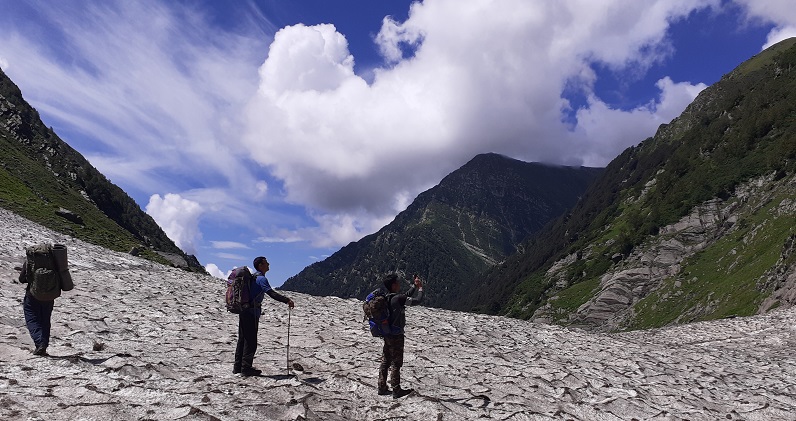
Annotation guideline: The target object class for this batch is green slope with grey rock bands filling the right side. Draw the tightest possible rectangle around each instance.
[464,39,796,330]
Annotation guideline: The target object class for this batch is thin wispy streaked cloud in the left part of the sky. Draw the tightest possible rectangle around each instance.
[0,0,269,226]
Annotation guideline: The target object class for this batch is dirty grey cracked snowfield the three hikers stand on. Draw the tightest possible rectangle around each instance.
[0,209,796,420]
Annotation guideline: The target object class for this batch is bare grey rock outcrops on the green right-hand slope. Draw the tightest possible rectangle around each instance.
[534,174,796,331]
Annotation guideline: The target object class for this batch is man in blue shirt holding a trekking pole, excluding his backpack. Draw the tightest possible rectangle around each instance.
[232,256,294,377]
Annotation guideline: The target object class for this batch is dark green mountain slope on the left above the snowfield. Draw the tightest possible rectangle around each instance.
[0,65,204,271]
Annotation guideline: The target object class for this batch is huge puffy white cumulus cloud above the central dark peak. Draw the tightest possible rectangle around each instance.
[244,0,720,244]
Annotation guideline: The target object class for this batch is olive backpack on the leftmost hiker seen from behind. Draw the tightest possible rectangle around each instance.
[25,243,61,301]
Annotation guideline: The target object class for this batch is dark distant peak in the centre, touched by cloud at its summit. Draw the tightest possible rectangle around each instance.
[283,154,601,307]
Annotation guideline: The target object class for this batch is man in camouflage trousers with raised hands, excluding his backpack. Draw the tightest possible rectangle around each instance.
[379,273,423,399]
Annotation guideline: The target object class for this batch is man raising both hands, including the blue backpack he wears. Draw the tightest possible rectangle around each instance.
[363,273,423,398]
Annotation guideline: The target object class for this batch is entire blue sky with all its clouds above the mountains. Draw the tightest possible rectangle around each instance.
[0,0,796,285]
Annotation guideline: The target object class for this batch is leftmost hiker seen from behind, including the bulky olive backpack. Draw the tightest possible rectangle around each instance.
[18,243,75,356]
